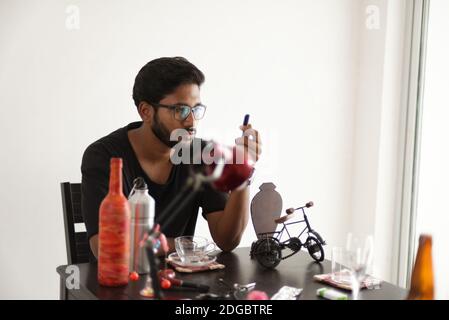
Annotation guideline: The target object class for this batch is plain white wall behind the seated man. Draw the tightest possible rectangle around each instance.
[0,0,406,299]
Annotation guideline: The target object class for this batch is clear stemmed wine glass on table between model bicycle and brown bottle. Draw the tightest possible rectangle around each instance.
[346,233,374,300]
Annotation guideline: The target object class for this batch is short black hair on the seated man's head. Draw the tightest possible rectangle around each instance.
[133,57,204,107]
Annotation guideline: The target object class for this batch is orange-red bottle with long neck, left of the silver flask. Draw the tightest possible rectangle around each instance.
[98,158,130,287]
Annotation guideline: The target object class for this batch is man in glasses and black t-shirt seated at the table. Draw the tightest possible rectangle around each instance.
[81,57,260,257]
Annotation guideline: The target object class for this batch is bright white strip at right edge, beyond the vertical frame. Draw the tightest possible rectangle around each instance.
[416,0,449,299]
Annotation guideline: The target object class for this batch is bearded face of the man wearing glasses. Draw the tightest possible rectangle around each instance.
[151,84,201,148]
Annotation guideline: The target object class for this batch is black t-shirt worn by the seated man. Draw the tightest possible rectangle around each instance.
[81,122,228,239]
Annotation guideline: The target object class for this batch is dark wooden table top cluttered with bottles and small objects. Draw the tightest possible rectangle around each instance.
[56,248,407,300]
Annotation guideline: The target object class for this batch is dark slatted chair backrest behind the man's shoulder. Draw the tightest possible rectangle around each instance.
[61,182,90,264]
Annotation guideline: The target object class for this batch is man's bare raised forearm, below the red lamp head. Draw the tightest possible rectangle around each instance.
[214,187,249,251]
